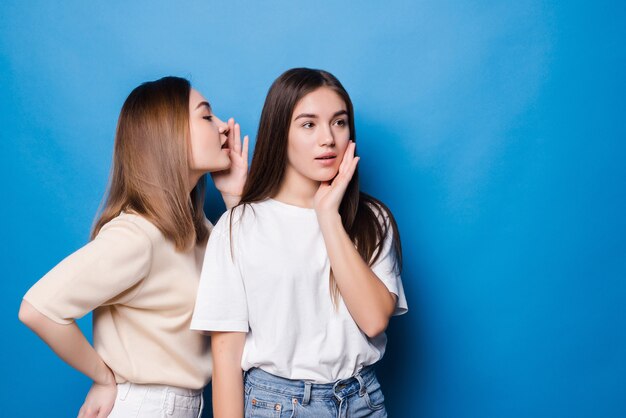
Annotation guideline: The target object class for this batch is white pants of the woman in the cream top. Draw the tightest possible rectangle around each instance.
[109,383,204,418]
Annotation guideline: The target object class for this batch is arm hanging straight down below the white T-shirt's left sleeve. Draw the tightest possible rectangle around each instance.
[211,332,245,418]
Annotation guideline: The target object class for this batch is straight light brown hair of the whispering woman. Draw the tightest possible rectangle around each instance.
[91,77,209,251]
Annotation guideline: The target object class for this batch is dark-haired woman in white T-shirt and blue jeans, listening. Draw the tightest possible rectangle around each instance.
[192,68,407,418]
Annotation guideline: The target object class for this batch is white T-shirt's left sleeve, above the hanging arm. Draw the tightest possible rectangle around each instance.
[191,211,249,332]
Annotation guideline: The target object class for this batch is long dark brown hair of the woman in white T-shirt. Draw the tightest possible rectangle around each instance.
[231,68,402,306]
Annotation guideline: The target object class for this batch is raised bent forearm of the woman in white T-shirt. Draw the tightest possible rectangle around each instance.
[318,213,395,337]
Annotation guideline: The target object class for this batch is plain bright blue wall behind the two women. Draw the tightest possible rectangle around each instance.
[0,0,626,418]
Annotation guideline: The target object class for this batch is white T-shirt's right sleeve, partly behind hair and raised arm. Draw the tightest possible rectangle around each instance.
[372,211,408,315]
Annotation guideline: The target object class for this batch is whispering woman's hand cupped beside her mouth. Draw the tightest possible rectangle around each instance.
[211,118,248,209]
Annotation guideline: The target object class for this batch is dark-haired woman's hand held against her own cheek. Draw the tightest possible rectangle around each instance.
[313,141,359,218]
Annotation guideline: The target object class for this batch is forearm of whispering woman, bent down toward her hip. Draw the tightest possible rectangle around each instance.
[19,300,115,384]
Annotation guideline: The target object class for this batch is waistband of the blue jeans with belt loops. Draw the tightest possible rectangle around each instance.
[244,365,376,404]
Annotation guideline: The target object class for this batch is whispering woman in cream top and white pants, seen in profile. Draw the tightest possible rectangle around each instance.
[19,77,248,418]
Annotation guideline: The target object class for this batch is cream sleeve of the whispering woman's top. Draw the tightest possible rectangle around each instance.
[24,218,152,324]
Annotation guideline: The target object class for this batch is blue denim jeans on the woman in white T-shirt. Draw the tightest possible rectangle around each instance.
[244,366,387,418]
